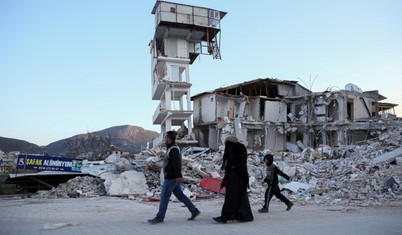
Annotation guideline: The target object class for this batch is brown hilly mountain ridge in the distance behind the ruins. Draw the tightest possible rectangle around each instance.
[0,125,158,157]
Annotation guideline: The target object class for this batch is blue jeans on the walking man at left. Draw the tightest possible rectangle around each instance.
[156,179,198,221]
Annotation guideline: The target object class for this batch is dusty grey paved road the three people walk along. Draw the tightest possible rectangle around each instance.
[0,197,402,235]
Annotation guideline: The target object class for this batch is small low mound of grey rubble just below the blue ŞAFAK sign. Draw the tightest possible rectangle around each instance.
[41,176,106,198]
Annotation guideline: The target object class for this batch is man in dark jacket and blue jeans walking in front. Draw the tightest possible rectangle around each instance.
[148,131,201,224]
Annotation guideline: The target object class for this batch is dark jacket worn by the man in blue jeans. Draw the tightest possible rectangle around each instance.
[163,143,182,179]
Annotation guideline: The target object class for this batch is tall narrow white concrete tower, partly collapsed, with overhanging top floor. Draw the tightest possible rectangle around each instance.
[149,1,226,146]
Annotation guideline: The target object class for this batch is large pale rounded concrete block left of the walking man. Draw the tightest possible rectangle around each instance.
[109,171,148,196]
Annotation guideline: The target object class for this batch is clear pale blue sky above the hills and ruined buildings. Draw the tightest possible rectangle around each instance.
[0,0,402,145]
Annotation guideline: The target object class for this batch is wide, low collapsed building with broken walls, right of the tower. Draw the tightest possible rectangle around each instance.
[191,78,400,152]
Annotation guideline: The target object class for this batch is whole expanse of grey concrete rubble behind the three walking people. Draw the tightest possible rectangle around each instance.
[33,127,402,206]
